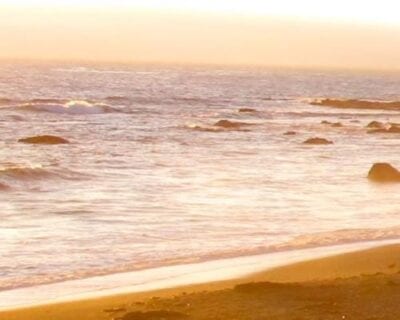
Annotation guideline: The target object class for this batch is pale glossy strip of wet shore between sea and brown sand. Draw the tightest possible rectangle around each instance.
[0,239,400,315]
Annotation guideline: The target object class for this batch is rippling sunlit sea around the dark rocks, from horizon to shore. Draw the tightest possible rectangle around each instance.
[0,63,400,290]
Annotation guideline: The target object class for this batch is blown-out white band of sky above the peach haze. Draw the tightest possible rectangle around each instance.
[0,0,400,23]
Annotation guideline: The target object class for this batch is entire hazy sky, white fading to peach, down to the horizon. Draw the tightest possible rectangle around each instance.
[0,0,400,69]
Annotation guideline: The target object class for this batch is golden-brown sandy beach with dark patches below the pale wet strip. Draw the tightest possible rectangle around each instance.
[0,245,400,320]
